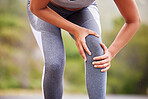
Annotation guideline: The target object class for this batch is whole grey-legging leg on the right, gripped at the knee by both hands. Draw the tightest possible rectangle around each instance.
[67,3,107,99]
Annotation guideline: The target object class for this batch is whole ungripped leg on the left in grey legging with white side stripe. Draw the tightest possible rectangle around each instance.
[28,1,65,99]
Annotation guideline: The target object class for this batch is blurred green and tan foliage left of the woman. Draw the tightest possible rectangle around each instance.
[0,0,42,89]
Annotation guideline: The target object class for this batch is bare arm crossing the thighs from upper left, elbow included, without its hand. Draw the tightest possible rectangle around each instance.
[30,0,80,33]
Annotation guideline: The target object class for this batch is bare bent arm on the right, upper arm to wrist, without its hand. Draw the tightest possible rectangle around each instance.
[108,0,141,57]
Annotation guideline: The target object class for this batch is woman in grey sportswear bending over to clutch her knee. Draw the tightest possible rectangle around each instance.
[27,0,140,99]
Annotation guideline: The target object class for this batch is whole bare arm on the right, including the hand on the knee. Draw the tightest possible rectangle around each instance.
[94,0,141,72]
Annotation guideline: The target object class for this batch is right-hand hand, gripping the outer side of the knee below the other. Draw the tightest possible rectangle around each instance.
[92,43,112,72]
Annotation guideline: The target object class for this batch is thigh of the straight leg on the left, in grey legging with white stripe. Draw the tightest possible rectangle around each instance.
[27,0,65,63]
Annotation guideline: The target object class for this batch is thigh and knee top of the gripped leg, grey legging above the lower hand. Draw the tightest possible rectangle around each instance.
[67,1,103,57]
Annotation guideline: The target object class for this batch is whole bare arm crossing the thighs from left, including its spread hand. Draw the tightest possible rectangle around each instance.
[30,0,99,61]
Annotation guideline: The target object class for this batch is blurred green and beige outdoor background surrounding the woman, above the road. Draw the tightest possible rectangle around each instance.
[0,0,148,98]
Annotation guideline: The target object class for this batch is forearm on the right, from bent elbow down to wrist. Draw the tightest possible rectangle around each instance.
[108,21,140,58]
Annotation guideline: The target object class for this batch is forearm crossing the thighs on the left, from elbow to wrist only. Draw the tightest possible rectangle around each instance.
[31,7,80,34]
